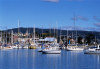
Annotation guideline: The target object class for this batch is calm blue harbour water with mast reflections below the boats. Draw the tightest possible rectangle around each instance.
[0,49,100,69]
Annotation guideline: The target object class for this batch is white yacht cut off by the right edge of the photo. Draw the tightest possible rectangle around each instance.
[84,45,100,54]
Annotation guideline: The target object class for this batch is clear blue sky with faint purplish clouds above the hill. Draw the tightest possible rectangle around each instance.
[0,0,100,31]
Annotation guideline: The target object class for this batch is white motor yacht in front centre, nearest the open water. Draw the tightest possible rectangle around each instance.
[42,45,61,54]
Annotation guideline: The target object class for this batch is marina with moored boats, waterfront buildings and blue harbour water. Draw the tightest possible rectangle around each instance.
[0,22,100,69]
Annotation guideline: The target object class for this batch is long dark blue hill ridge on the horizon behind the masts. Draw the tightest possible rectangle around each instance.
[5,27,100,38]
